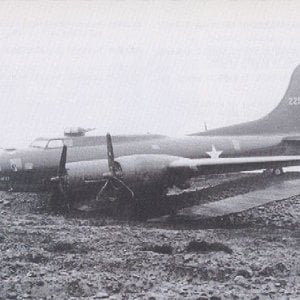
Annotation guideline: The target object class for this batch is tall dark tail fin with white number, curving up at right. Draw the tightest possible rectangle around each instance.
[195,65,300,135]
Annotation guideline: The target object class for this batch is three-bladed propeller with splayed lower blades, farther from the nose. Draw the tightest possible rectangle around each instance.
[97,133,134,199]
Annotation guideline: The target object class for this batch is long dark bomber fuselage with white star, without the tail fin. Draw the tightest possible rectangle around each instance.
[0,135,291,191]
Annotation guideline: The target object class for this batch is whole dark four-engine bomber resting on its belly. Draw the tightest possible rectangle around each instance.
[0,66,300,212]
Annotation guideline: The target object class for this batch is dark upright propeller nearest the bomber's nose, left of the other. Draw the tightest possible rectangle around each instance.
[50,145,70,210]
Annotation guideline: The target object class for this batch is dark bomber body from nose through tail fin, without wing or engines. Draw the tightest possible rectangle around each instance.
[0,66,300,191]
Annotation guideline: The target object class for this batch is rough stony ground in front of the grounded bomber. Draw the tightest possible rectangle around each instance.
[0,175,300,300]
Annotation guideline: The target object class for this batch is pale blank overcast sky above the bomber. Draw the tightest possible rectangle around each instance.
[0,0,300,147]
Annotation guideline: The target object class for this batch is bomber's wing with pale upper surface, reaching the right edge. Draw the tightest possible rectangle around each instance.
[169,156,300,175]
